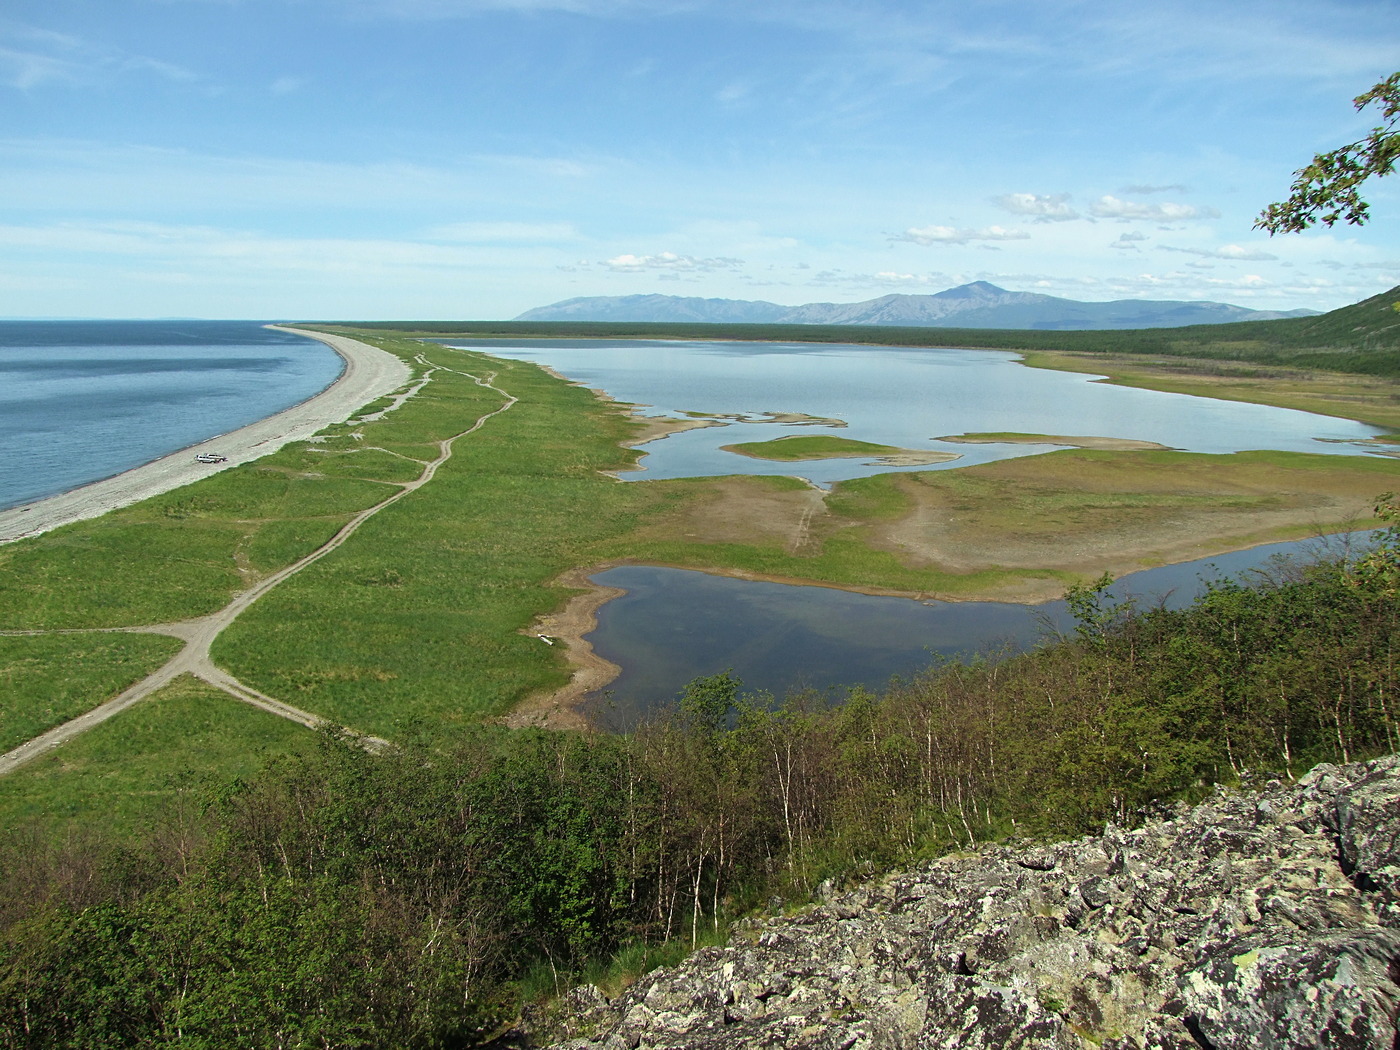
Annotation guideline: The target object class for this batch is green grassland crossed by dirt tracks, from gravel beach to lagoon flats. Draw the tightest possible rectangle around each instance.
[0,332,1400,840]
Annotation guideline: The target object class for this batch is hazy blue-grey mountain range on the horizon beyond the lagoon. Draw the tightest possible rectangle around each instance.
[515,281,1316,330]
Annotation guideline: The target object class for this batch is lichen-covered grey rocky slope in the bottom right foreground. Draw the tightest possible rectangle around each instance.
[540,757,1400,1050]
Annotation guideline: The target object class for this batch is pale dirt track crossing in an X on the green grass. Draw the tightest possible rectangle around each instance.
[0,368,519,776]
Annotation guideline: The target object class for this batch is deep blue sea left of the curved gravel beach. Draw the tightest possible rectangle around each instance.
[0,321,344,508]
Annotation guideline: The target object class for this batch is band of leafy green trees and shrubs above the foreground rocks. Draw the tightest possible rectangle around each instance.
[0,504,1400,1050]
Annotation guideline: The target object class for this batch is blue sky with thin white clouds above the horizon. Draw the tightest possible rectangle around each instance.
[0,0,1400,319]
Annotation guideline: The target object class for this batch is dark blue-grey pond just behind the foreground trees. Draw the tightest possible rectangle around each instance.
[584,533,1369,731]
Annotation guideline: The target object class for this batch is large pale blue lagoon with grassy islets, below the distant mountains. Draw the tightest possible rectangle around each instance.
[451,340,1380,486]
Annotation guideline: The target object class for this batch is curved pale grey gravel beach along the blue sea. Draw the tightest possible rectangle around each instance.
[0,325,413,543]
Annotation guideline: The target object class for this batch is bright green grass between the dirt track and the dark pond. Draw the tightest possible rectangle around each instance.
[214,347,660,739]
